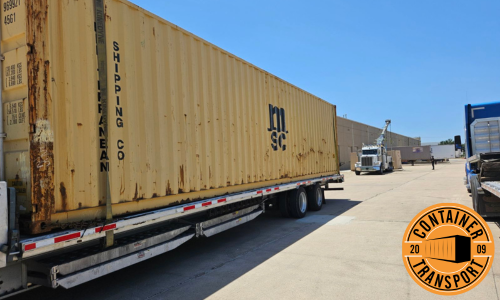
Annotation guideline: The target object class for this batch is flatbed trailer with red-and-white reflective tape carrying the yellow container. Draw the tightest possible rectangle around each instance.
[0,175,344,299]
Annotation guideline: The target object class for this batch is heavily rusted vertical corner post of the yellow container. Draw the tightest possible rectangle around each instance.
[26,0,55,234]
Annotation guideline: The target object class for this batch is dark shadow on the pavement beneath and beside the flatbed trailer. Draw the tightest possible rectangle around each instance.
[9,199,361,300]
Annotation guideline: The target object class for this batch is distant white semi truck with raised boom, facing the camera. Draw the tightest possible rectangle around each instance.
[355,120,394,175]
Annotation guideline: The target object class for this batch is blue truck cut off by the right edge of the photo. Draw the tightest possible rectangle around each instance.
[464,102,500,217]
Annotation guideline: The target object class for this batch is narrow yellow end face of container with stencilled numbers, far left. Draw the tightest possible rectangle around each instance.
[1,0,33,230]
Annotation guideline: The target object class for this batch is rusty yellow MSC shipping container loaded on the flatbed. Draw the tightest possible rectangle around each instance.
[2,0,338,233]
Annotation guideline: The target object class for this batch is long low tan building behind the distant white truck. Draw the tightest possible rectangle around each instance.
[337,117,421,170]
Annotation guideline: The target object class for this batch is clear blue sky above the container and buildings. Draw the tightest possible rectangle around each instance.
[132,0,500,142]
